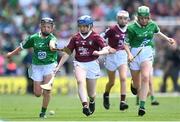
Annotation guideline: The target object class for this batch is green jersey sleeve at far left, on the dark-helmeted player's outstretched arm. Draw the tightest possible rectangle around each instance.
[20,36,34,49]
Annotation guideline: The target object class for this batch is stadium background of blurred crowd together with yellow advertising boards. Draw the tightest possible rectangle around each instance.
[0,0,180,94]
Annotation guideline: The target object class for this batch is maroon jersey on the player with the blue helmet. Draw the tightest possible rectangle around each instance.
[67,31,105,62]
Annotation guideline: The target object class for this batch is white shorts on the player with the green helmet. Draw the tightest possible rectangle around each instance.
[129,46,154,70]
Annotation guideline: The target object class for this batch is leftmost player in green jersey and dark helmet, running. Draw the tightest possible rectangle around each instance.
[6,18,59,118]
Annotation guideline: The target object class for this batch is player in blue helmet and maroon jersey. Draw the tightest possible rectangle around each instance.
[55,15,109,116]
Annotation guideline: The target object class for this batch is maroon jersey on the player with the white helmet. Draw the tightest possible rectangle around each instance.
[104,25,125,50]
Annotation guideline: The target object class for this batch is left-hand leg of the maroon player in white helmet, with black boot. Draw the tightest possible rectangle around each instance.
[103,70,115,109]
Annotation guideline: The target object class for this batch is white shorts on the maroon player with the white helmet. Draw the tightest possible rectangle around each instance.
[105,50,127,71]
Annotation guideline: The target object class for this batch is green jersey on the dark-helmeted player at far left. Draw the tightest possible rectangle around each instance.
[20,33,57,65]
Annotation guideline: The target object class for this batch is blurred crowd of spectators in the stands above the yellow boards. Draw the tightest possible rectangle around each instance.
[0,0,180,79]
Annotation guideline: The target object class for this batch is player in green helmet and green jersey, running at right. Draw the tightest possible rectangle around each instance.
[126,6,175,116]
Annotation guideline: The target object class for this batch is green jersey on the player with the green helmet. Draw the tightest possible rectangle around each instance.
[125,20,160,48]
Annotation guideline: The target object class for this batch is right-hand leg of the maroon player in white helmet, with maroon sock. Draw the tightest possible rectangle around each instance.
[118,64,128,110]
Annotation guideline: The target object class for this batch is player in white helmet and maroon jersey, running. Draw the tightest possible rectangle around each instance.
[97,10,133,111]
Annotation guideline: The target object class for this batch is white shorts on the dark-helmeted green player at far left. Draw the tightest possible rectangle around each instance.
[28,63,57,82]
